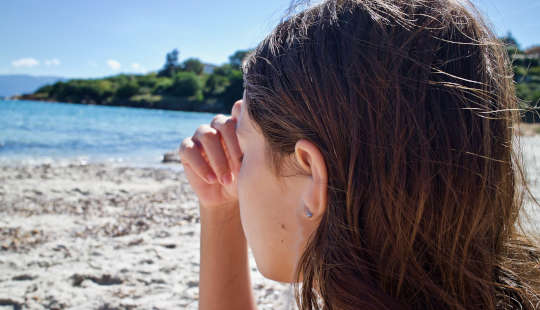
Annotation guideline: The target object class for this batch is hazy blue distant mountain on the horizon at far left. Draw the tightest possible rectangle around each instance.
[0,74,66,97]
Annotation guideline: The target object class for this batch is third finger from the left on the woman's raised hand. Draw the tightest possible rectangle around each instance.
[210,114,242,174]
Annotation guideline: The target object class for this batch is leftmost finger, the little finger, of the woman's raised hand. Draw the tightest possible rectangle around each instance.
[179,138,217,184]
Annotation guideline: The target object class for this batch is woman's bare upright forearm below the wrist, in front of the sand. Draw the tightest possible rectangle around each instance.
[199,205,256,310]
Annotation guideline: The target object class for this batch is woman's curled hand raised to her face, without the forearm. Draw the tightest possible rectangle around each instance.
[179,100,242,207]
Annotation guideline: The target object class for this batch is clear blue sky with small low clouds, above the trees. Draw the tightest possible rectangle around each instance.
[0,0,540,78]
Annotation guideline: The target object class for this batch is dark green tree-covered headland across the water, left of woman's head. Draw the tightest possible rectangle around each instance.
[20,49,249,113]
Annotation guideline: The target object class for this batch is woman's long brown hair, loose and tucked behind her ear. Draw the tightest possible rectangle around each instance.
[243,0,540,309]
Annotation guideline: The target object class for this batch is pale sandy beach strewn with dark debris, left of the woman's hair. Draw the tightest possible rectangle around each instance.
[0,164,294,310]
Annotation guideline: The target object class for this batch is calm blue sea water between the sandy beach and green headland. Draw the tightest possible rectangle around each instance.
[0,100,213,166]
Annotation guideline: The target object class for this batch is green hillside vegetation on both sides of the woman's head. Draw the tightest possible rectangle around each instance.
[21,33,540,122]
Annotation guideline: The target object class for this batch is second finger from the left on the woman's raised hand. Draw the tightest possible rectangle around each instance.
[193,125,232,185]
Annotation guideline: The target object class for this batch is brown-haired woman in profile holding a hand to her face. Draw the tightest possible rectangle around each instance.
[180,0,540,309]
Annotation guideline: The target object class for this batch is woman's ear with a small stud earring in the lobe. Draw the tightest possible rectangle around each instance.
[294,139,328,220]
